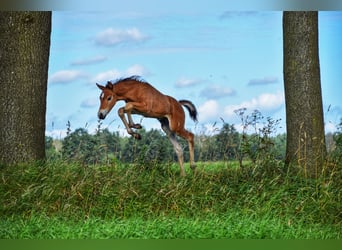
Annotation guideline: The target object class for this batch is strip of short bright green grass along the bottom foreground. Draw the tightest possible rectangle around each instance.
[0,211,341,239]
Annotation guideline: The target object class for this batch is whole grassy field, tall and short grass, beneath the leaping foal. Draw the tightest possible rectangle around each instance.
[0,162,342,239]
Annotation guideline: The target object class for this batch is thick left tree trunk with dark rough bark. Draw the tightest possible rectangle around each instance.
[0,12,51,164]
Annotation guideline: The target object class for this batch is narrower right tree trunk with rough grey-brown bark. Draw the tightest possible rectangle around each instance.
[283,12,326,177]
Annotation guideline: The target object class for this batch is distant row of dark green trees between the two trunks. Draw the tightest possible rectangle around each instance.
[52,109,285,166]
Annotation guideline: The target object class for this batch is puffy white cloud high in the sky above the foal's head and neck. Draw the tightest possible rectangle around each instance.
[95,28,148,46]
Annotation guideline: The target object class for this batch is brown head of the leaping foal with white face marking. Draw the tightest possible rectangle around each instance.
[96,82,117,119]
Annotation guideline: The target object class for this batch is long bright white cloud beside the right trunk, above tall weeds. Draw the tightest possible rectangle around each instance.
[224,92,285,117]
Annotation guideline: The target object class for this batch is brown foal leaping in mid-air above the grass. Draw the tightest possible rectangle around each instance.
[96,76,197,176]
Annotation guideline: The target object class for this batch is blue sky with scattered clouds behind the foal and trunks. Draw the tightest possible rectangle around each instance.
[46,8,342,138]
